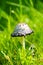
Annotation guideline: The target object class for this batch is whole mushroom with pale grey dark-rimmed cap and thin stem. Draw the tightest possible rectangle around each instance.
[11,23,33,49]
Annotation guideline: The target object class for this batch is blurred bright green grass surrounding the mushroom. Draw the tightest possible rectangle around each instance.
[0,0,43,65]
